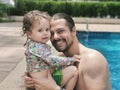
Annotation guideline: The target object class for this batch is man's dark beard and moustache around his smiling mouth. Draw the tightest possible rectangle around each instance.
[52,38,73,52]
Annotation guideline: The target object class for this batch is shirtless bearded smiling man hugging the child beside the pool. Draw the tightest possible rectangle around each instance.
[26,13,111,90]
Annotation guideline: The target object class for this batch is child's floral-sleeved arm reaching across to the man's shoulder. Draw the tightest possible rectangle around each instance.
[30,44,75,66]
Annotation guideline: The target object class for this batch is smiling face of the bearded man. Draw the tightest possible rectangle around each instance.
[50,19,73,52]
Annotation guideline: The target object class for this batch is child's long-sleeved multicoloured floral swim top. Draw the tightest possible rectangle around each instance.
[25,41,74,72]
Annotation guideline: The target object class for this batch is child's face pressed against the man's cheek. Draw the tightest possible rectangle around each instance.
[28,18,51,43]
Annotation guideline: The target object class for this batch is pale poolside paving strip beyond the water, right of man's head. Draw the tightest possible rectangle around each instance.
[75,23,120,32]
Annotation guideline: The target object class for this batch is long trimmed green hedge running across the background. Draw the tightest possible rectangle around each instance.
[6,0,120,18]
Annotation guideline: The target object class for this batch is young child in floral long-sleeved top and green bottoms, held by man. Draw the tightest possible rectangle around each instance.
[23,10,79,90]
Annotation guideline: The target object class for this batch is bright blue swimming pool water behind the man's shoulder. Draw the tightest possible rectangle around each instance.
[77,31,120,90]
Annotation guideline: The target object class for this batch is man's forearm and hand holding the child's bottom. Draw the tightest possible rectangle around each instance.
[25,73,64,90]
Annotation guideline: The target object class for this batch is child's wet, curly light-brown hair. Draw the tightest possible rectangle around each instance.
[22,10,51,35]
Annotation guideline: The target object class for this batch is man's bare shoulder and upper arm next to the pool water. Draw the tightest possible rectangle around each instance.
[82,51,111,90]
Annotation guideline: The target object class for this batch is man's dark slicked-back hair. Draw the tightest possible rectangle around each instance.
[52,13,75,31]
